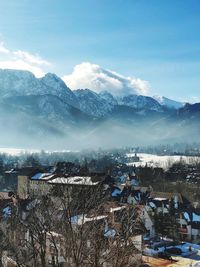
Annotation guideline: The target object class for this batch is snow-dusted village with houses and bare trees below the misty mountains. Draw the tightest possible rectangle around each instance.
[0,152,200,267]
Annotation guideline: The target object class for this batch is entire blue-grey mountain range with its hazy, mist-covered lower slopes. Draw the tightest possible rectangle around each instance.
[0,70,200,148]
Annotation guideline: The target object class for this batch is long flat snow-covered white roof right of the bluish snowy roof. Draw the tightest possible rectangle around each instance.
[48,176,98,185]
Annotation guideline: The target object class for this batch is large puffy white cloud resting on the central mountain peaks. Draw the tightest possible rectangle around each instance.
[63,62,150,96]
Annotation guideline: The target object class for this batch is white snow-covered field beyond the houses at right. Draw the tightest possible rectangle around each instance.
[127,153,200,169]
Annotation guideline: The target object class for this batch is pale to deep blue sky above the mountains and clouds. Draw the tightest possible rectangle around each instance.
[0,0,200,101]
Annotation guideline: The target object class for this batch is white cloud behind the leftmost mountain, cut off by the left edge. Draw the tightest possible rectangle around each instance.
[0,41,51,77]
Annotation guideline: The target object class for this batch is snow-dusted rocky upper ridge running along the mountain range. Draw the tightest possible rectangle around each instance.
[0,70,191,121]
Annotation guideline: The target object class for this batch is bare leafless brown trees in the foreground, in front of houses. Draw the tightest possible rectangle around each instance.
[0,186,143,267]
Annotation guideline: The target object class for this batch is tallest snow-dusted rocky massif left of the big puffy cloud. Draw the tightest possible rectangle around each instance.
[0,69,78,107]
